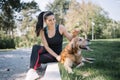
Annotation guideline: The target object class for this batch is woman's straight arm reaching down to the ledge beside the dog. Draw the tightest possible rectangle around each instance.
[40,30,59,61]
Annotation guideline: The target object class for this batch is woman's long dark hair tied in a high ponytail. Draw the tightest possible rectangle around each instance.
[35,11,54,36]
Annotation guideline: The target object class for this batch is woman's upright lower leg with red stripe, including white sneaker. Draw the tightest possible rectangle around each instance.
[25,45,43,80]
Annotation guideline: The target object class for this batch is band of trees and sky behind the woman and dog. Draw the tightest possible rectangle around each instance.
[0,0,120,49]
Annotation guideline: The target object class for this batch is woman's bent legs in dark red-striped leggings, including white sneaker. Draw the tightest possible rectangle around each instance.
[25,45,56,80]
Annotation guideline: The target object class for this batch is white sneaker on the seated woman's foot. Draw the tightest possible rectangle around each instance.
[25,69,39,80]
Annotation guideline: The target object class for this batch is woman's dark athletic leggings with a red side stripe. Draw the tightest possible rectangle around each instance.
[30,45,57,70]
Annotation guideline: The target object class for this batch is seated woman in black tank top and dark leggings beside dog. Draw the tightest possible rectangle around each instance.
[26,11,79,79]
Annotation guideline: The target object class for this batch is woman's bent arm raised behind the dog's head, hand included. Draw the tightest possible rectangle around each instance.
[59,25,80,41]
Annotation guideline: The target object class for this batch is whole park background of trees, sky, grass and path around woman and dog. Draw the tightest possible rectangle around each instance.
[0,0,120,80]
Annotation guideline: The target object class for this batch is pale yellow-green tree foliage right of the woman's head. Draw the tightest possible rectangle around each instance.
[47,0,120,39]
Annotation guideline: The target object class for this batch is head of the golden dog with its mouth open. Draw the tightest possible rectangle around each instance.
[71,37,90,50]
